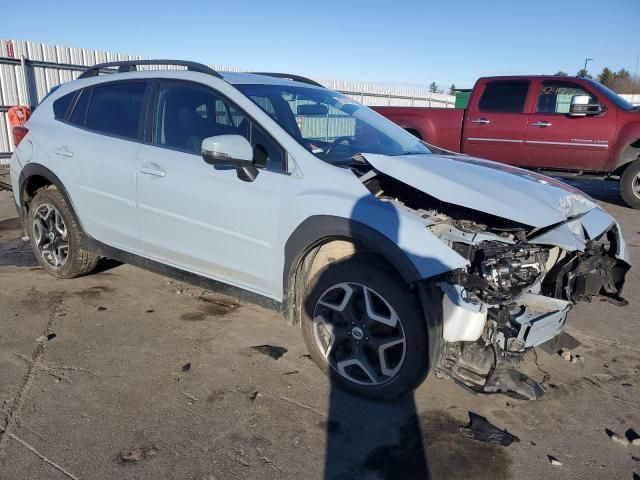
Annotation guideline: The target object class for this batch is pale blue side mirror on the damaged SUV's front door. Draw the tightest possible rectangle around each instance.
[202,135,259,182]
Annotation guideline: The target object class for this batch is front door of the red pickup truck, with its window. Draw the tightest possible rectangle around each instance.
[524,80,616,171]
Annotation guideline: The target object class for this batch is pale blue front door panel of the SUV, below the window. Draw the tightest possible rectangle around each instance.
[137,145,288,294]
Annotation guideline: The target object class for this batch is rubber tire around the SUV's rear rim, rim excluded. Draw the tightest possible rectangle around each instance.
[26,186,100,278]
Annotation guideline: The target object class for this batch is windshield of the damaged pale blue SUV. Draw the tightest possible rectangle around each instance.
[236,84,431,164]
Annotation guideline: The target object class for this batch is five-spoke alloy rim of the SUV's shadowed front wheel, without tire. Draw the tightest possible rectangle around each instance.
[313,282,406,386]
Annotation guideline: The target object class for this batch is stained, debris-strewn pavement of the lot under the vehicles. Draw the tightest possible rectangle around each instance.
[0,173,640,480]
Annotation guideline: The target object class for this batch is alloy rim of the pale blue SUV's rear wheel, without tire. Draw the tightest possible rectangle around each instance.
[33,203,69,269]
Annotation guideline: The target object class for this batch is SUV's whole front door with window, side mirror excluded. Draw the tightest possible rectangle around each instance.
[137,81,289,296]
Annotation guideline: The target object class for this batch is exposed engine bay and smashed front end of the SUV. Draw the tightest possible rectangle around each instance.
[360,170,629,399]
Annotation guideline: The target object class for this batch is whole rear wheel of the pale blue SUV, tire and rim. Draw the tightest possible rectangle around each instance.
[25,186,100,278]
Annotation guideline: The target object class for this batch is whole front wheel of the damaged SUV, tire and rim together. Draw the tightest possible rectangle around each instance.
[302,255,429,400]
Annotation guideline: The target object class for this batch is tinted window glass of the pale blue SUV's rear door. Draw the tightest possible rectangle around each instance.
[85,81,147,138]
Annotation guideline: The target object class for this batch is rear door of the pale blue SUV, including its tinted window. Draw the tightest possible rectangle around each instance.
[50,80,149,252]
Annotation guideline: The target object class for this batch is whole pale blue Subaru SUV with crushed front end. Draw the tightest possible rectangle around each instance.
[11,60,629,399]
